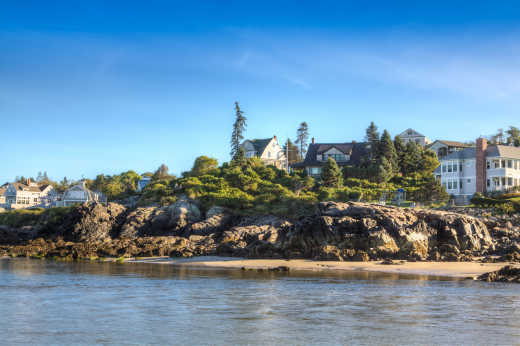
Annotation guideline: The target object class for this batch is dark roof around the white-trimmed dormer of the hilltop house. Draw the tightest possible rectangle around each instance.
[291,142,369,168]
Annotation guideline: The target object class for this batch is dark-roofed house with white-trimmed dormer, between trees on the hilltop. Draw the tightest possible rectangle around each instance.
[291,138,370,178]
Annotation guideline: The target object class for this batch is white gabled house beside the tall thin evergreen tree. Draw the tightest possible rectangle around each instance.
[241,136,287,169]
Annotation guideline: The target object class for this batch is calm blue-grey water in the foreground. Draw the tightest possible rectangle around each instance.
[0,259,520,345]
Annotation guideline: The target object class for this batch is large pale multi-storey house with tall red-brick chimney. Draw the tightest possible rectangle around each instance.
[435,138,520,204]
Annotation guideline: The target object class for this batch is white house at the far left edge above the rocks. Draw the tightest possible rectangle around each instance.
[4,179,58,209]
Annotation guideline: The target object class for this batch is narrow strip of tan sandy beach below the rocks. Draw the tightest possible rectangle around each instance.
[131,257,510,278]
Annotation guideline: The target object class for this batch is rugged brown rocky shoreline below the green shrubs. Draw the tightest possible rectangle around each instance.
[0,199,520,274]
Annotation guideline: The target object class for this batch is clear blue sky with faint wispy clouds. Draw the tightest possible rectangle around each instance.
[0,1,520,182]
